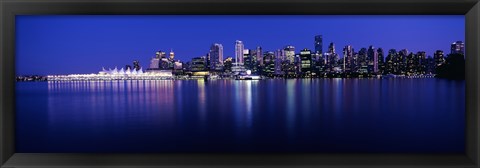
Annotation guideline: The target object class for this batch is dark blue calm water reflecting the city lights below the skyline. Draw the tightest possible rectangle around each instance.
[16,78,465,153]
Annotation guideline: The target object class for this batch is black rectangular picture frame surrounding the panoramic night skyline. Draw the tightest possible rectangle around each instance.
[0,0,480,168]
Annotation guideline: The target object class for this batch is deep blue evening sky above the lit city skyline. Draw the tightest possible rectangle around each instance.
[16,15,465,75]
